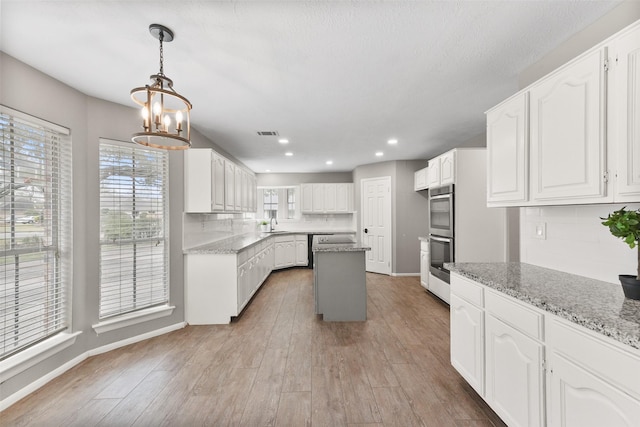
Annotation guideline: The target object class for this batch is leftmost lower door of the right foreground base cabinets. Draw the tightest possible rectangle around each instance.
[450,294,484,396]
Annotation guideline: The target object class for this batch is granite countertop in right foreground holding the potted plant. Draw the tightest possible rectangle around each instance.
[445,262,640,349]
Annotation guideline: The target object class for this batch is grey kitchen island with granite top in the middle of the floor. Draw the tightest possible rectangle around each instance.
[312,236,371,322]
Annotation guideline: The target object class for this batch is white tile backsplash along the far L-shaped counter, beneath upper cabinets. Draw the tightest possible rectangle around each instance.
[182,214,356,249]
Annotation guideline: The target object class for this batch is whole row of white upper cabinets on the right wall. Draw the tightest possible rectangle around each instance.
[487,22,640,206]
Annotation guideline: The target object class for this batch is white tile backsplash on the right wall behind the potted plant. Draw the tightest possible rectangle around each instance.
[520,203,640,283]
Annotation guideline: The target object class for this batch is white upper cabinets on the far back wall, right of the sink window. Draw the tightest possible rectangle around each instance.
[300,183,353,213]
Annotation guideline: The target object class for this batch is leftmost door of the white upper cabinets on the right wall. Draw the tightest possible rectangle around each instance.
[487,92,529,206]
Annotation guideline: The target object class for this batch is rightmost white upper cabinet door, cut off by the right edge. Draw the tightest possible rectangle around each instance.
[611,25,640,202]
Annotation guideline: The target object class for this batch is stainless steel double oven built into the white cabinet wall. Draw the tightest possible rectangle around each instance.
[429,184,455,283]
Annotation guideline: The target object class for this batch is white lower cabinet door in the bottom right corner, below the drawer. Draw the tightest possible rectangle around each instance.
[547,352,640,427]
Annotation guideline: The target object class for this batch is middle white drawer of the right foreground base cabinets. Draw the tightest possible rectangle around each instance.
[484,290,544,340]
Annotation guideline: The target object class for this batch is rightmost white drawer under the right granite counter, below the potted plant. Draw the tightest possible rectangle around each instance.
[545,315,640,399]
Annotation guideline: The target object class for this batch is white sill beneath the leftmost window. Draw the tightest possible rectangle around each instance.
[0,332,82,384]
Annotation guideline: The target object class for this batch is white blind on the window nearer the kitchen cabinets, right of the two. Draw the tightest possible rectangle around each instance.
[99,139,169,319]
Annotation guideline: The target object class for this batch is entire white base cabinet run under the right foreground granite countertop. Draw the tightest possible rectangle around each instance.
[451,273,640,427]
